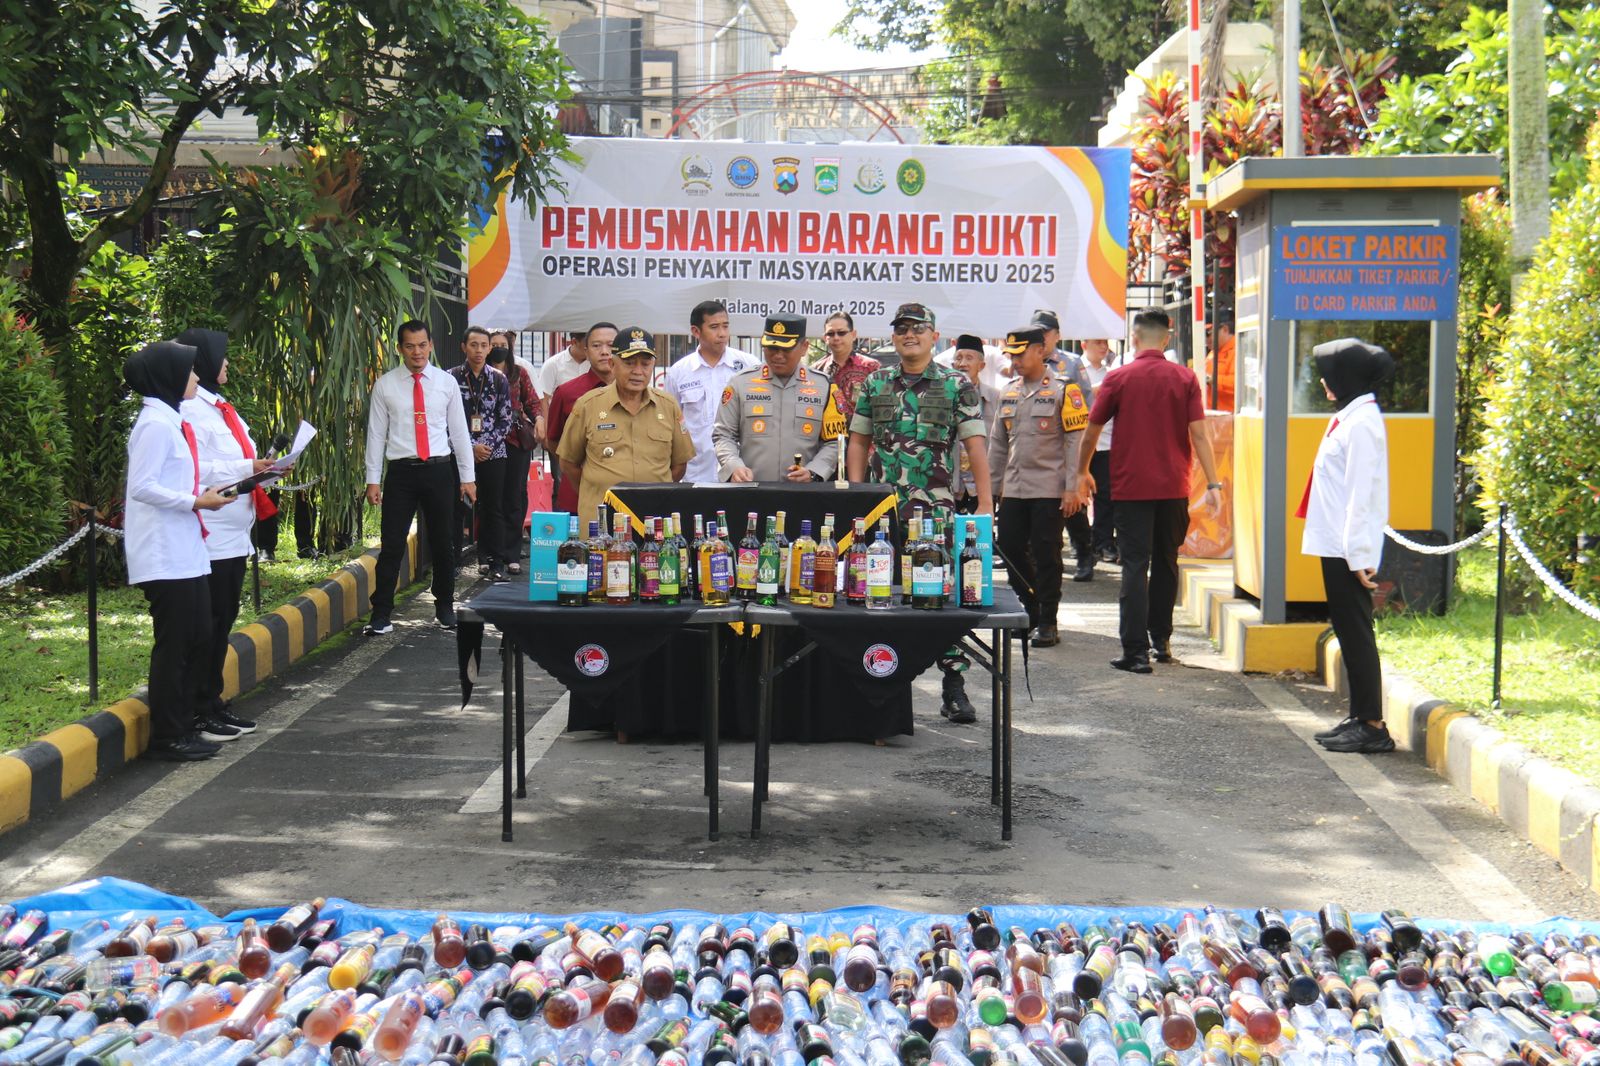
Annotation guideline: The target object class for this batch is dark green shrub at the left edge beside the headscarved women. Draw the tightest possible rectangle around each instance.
[0,277,72,573]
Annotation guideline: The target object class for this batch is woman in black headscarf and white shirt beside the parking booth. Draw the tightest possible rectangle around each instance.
[1299,338,1395,754]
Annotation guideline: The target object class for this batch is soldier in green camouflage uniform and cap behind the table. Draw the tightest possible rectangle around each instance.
[848,304,994,722]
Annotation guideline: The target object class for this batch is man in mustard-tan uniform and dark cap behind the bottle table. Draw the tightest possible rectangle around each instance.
[557,327,694,520]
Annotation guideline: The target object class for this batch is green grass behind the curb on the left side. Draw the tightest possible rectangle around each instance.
[0,509,378,751]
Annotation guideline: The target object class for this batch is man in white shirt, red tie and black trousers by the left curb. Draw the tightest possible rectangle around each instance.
[366,319,478,635]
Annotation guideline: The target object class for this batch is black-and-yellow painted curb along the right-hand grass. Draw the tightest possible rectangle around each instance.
[1317,631,1600,892]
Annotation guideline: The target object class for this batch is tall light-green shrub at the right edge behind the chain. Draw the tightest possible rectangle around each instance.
[1477,136,1600,602]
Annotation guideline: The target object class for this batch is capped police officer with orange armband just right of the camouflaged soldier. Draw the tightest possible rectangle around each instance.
[989,325,1090,648]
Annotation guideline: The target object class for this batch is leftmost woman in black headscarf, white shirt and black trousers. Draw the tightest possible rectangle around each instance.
[122,341,227,762]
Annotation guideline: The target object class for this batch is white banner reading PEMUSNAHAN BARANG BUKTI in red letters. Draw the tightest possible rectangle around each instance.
[467,138,1130,338]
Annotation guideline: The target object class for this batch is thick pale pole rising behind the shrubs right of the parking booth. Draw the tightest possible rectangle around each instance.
[1509,0,1550,296]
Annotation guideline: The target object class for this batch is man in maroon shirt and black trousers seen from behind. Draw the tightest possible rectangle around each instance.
[1078,311,1222,674]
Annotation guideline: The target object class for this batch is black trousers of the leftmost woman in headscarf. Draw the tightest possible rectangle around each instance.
[139,575,211,741]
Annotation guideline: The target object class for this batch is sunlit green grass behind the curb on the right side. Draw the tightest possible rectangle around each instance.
[1378,536,1600,786]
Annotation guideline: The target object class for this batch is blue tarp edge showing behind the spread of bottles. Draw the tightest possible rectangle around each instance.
[11,877,1600,936]
